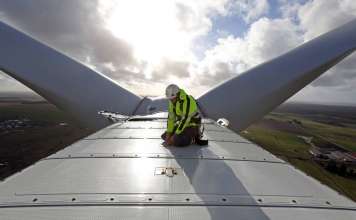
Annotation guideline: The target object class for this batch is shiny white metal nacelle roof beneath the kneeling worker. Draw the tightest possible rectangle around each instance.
[0,119,356,220]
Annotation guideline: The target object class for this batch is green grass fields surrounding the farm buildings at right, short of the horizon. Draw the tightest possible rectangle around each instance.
[241,113,356,201]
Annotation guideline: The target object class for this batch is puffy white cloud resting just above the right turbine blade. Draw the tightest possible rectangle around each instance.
[196,18,302,86]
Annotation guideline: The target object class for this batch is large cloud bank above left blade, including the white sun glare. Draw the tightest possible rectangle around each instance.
[0,0,234,94]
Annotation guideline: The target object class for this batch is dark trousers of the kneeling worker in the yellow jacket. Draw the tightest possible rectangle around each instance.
[161,127,199,147]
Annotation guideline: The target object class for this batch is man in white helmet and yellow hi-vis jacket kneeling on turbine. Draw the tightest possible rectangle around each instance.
[162,84,201,147]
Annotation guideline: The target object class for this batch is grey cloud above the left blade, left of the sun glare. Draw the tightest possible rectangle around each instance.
[0,0,143,91]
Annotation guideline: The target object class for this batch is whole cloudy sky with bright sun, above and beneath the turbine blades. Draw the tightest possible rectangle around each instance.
[0,0,356,104]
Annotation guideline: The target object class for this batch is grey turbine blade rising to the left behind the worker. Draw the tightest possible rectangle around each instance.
[0,22,142,129]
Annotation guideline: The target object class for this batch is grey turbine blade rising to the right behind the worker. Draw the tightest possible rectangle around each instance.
[198,20,356,132]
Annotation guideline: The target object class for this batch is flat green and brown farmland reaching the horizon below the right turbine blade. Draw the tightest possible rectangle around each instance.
[241,104,356,201]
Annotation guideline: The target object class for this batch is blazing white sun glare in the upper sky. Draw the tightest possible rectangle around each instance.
[101,0,191,65]
